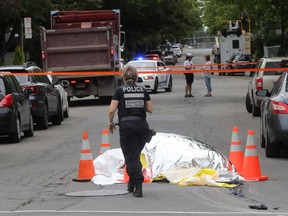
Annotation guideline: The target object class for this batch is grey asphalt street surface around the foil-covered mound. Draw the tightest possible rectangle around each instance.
[0,50,288,216]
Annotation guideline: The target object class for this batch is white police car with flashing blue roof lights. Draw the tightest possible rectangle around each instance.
[127,60,173,93]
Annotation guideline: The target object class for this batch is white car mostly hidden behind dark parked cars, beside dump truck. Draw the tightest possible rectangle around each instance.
[47,75,69,118]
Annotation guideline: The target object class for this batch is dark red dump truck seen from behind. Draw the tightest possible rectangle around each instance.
[40,10,125,103]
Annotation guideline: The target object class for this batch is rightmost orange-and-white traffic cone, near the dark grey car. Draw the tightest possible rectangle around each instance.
[242,130,268,181]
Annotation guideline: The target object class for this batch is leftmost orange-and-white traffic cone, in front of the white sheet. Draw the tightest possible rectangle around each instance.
[73,132,95,182]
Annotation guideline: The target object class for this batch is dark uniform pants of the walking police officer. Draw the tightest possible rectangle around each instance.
[119,120,149,184]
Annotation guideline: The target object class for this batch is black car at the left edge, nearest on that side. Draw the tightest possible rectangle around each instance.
[0,72,34,143]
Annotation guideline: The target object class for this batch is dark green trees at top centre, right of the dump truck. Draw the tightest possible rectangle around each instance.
[102,0,202,59]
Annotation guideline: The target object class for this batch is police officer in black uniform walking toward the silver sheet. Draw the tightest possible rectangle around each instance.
[108,65,153,197]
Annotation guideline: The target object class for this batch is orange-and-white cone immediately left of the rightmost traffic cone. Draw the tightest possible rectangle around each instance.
[229,127,244,174]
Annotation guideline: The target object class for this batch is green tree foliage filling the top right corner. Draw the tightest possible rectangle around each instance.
[203,0,288,58]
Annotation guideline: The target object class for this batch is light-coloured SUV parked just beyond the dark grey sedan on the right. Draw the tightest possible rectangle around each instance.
[245,57,288,116]
